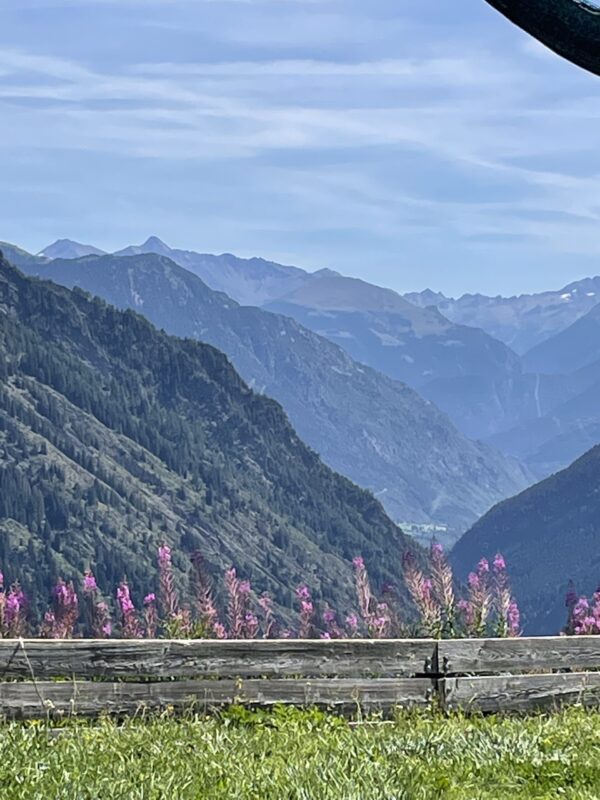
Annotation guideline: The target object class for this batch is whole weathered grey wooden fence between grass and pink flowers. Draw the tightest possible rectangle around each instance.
[0,636,600,718]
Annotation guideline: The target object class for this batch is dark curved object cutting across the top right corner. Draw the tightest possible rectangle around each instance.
[486,0,600,75]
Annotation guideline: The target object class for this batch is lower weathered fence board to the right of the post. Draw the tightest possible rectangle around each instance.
[440,672,600,713]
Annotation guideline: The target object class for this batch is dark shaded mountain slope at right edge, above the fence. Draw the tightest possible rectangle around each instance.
[452,446,600,634]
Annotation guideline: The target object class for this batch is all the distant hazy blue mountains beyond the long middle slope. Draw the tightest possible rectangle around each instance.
[22,238,600,488]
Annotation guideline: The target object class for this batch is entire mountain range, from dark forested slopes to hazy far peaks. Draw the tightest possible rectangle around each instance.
[0,237,600,634]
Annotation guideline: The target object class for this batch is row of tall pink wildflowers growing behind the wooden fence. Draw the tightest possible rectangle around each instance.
[0,544,520,639]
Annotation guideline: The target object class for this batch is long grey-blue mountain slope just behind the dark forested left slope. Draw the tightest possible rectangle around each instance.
[1,242,531,538]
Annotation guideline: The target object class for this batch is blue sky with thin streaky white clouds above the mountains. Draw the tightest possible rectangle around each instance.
[0,0,600,296]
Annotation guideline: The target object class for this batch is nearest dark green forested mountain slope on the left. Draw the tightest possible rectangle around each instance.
[0,257,418,610]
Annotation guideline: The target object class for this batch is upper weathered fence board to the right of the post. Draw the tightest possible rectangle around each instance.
[438,636,600,674]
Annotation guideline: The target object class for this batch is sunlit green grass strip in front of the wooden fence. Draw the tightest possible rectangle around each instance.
[0,709,600,800]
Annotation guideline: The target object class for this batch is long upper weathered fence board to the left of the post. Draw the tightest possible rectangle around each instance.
[0,639,437,681]
